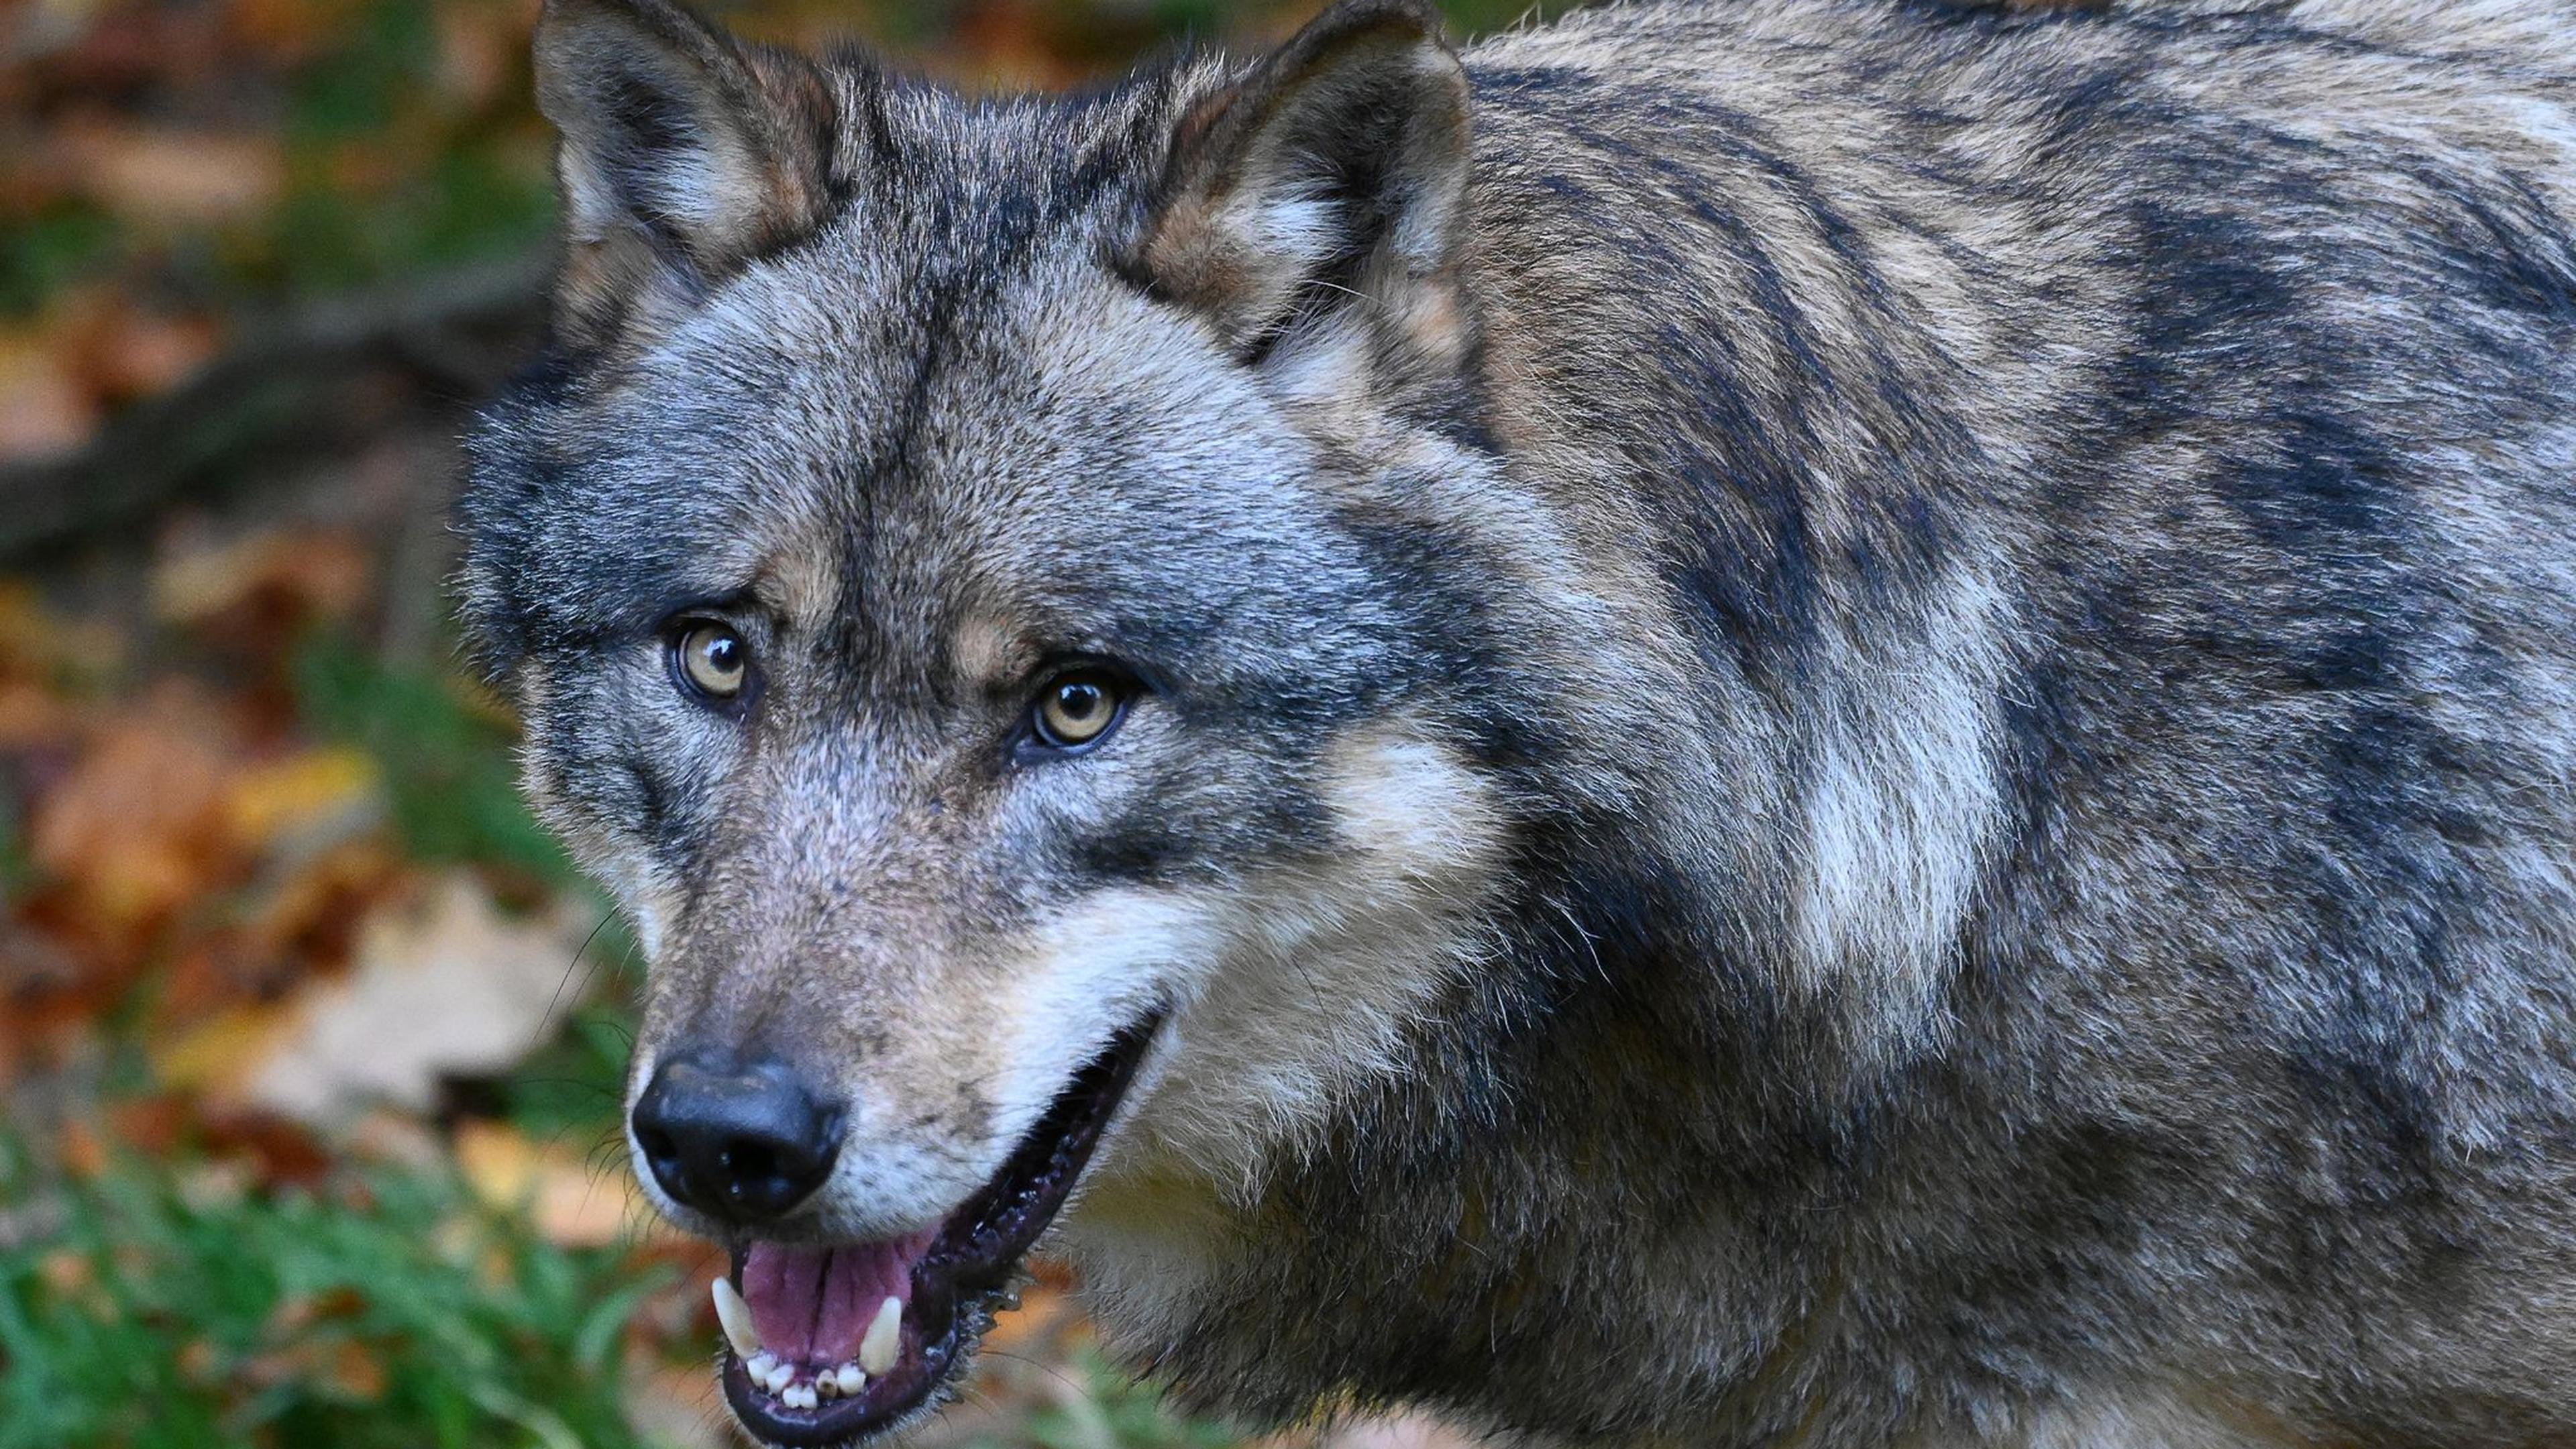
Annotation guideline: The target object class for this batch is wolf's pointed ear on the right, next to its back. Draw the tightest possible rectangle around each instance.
[1136,0,1468,358]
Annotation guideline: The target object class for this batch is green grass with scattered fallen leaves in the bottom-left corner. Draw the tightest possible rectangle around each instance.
[0,1139,662,1449]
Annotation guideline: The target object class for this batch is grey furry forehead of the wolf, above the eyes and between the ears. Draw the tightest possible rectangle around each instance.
[461,62,1401,673]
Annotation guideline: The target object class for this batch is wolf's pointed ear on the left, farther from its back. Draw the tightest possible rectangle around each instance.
[536,0,837,348]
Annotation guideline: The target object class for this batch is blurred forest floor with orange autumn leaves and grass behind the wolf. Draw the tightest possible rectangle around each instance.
[0,0,1517,1449]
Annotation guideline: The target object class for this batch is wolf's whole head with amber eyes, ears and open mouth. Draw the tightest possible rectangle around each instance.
[464,0,1615,1439]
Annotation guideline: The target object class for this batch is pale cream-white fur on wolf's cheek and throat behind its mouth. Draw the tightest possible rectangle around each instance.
[1051,724,1502,1312]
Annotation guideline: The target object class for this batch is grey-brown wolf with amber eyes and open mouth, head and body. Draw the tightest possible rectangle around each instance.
[461,0,2576,1449]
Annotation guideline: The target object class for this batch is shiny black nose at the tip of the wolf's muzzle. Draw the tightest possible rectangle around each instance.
[634,1046,840,1222]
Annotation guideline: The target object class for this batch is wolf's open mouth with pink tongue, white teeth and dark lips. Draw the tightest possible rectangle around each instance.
[716,1013,1162,1449]
